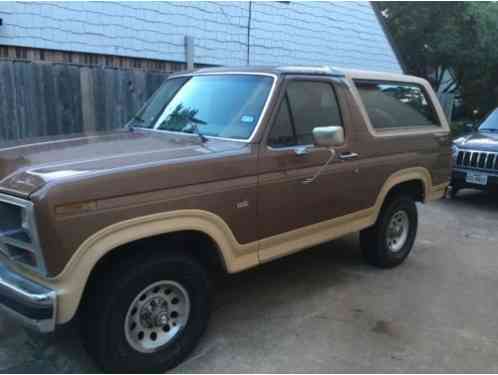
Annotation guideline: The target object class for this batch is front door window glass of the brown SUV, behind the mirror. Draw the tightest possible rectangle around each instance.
[269,81,342,147]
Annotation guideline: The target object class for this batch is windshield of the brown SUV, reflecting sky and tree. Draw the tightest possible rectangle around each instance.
[131,75,273,140]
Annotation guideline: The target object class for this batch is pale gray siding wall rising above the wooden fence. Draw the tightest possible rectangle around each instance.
[0,2,401,72]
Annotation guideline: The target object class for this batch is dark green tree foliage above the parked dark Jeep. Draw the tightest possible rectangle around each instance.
[377,1,498,116]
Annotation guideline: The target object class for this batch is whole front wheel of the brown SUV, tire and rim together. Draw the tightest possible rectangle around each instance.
[82,254,209,373]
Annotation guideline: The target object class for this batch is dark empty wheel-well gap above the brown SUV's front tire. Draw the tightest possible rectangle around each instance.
[78,230,226,318]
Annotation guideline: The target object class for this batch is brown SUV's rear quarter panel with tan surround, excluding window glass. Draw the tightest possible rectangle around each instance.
[346,76,451,207]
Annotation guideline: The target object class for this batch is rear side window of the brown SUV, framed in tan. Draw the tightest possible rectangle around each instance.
[355,80,441,129]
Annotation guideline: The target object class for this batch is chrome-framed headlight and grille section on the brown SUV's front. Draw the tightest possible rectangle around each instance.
[0,194,46,274]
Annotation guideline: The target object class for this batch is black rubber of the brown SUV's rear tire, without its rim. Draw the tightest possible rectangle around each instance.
[360,195,418,268]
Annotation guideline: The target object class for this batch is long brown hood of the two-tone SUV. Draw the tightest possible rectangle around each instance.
[0,129,243,197]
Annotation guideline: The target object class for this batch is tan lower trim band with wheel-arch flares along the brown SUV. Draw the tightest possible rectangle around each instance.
[10,168,440,324]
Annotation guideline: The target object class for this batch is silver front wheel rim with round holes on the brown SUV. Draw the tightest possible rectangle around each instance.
[124,280,190,353]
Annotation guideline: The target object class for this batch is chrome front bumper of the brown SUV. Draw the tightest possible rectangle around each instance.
[0,263,57,333]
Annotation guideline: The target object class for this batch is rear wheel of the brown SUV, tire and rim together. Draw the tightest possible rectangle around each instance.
[360,195,418,268]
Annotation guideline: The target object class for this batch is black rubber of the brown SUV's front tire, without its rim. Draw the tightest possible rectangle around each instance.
[82,253,210,373]
